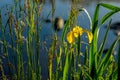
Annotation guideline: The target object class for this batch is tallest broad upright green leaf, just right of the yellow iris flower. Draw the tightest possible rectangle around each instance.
[89,4,99,78]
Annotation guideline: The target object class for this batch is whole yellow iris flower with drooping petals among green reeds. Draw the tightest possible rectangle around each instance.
[67,26,93,43]
